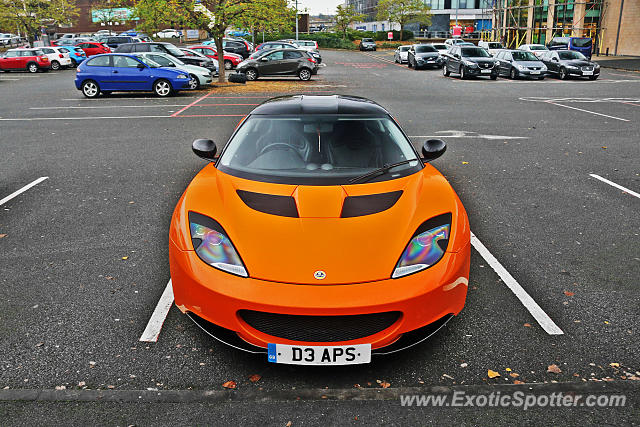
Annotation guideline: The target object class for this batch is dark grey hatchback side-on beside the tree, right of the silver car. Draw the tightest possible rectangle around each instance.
[236,49,318,80]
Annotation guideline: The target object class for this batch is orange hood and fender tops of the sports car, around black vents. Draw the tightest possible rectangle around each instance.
[171,165,469,285]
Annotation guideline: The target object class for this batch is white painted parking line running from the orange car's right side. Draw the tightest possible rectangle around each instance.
[471,233,564,335]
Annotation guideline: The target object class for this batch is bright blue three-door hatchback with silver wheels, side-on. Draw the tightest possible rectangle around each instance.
[75,53,191,98]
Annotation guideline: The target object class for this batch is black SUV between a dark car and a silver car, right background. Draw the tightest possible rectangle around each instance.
[442,45,498,80]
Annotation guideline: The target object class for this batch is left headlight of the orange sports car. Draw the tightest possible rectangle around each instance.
[189,212,249,277]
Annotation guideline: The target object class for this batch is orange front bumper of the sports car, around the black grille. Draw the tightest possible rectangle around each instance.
[169,240,470,350]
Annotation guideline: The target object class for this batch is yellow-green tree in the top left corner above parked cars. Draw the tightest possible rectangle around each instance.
[0,0,78,43]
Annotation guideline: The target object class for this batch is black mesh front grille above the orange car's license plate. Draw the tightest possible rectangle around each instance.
[238,310,401,342]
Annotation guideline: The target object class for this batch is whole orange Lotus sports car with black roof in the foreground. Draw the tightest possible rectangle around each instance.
[169,95,470,365]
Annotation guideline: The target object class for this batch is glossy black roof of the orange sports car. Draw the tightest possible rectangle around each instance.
[251,95,389,117]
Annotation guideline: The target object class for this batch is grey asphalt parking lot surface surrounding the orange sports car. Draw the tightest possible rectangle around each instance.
[0,51,640,425]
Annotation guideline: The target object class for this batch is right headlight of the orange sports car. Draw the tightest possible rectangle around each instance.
[391,214,451,279]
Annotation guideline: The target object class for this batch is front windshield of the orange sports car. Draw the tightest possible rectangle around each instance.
[218,114,422,185]
